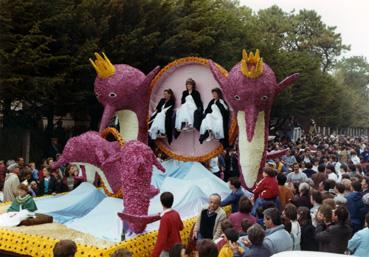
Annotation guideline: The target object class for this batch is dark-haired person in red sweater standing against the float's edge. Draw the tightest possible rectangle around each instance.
[151,192,183,257]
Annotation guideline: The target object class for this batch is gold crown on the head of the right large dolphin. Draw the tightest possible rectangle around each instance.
[241,49,264,79]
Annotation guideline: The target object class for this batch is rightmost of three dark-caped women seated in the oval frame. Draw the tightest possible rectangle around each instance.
[199,88,229,147]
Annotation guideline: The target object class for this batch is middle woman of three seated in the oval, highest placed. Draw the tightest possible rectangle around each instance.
[175,78,203,131]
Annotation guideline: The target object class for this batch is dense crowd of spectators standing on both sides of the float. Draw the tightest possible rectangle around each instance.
[0,132,369,257]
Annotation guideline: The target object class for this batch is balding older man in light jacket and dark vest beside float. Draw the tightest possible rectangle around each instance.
[192,194,227,240]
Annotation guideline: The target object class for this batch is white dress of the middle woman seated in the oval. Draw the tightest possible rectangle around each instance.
[175,95,197,130]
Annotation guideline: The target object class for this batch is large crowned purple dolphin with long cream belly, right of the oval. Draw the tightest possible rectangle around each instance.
[209,51,298,188]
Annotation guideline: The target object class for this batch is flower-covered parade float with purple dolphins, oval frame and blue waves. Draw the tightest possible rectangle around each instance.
[0,51,298,257]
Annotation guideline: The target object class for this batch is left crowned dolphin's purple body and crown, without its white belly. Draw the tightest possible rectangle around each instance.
[90,52,160,143]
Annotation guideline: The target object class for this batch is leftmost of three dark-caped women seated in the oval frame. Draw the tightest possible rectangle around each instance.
[149,89,175,144]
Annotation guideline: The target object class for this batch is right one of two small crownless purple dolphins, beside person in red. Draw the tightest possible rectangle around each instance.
[111,140,164,233]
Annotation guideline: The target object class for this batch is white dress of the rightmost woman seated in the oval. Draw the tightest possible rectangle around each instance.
[200,99,228,140]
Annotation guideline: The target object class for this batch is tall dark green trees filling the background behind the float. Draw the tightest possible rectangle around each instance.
[0,0,369,127]
